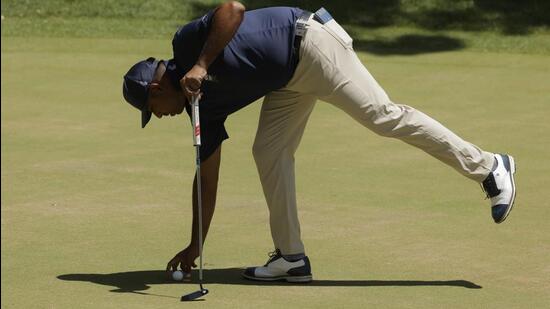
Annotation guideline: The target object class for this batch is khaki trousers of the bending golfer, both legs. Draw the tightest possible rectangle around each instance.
[253,19,494,254]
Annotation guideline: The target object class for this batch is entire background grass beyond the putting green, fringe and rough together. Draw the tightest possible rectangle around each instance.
[2,0,550,54]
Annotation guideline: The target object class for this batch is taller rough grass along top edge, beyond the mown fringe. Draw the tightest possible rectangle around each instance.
[2,0,550,34]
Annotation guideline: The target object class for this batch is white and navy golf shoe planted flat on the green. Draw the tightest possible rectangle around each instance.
[243,249,312,283]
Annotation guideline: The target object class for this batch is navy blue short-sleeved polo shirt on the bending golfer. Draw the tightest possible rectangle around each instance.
[169,7,303,159]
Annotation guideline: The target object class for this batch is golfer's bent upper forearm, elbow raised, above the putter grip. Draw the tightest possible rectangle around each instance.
[197,1,245,70]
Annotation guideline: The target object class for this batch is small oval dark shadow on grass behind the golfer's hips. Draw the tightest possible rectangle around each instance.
[353,34,466,55]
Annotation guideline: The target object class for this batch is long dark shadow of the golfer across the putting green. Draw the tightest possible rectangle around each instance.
[57,268,482,296]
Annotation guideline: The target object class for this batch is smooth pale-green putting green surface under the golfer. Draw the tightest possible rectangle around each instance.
[1,37,550,308]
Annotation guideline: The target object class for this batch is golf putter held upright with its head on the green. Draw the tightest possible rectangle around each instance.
[181,96,208,301]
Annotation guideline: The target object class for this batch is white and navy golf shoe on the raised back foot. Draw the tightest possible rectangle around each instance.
[482,154,516,223]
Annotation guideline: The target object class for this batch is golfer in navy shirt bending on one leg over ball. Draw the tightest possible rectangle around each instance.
[123,1,515,282]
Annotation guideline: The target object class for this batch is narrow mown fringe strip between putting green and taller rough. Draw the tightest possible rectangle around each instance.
[2,17,550,56]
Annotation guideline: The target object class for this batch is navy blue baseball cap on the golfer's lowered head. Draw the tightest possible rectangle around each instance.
[122,57,166,128]
